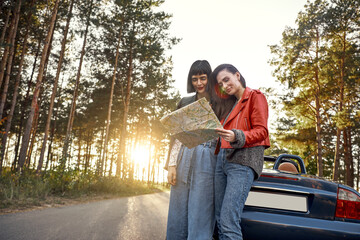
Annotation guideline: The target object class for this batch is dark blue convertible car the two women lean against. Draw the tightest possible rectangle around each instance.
[241,154,360,240]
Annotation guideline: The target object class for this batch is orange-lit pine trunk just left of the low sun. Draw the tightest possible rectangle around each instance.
[116,36,134,177]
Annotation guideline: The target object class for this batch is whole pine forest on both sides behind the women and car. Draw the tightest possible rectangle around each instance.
[0,0,360,207]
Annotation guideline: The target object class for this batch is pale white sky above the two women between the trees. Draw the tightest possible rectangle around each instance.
[160,0,307,96]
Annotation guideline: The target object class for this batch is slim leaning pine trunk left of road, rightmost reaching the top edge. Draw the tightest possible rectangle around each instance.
[60,1,93,171]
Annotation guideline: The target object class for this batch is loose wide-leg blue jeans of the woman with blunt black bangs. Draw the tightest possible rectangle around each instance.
[166,142,216,240]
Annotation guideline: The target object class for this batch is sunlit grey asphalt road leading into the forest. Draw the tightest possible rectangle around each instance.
[0,192,169,240]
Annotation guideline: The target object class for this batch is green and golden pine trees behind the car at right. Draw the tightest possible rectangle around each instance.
[269,0,360,184]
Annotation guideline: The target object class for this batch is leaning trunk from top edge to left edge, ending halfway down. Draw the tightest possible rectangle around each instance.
[0,0,21,119]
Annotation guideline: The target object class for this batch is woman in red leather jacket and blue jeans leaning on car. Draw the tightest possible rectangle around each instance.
[210,64,270,239]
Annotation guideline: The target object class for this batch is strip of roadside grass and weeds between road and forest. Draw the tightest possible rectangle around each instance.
[0,171,168,213]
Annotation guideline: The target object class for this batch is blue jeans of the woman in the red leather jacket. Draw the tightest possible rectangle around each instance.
[215,149,254,240]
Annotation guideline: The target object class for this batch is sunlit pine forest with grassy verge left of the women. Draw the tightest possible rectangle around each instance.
[0,0,179,214]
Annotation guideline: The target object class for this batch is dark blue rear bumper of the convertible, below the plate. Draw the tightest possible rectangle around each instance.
[241,210,360,240]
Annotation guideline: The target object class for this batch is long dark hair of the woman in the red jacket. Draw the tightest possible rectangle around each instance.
[208,64,246,120]
